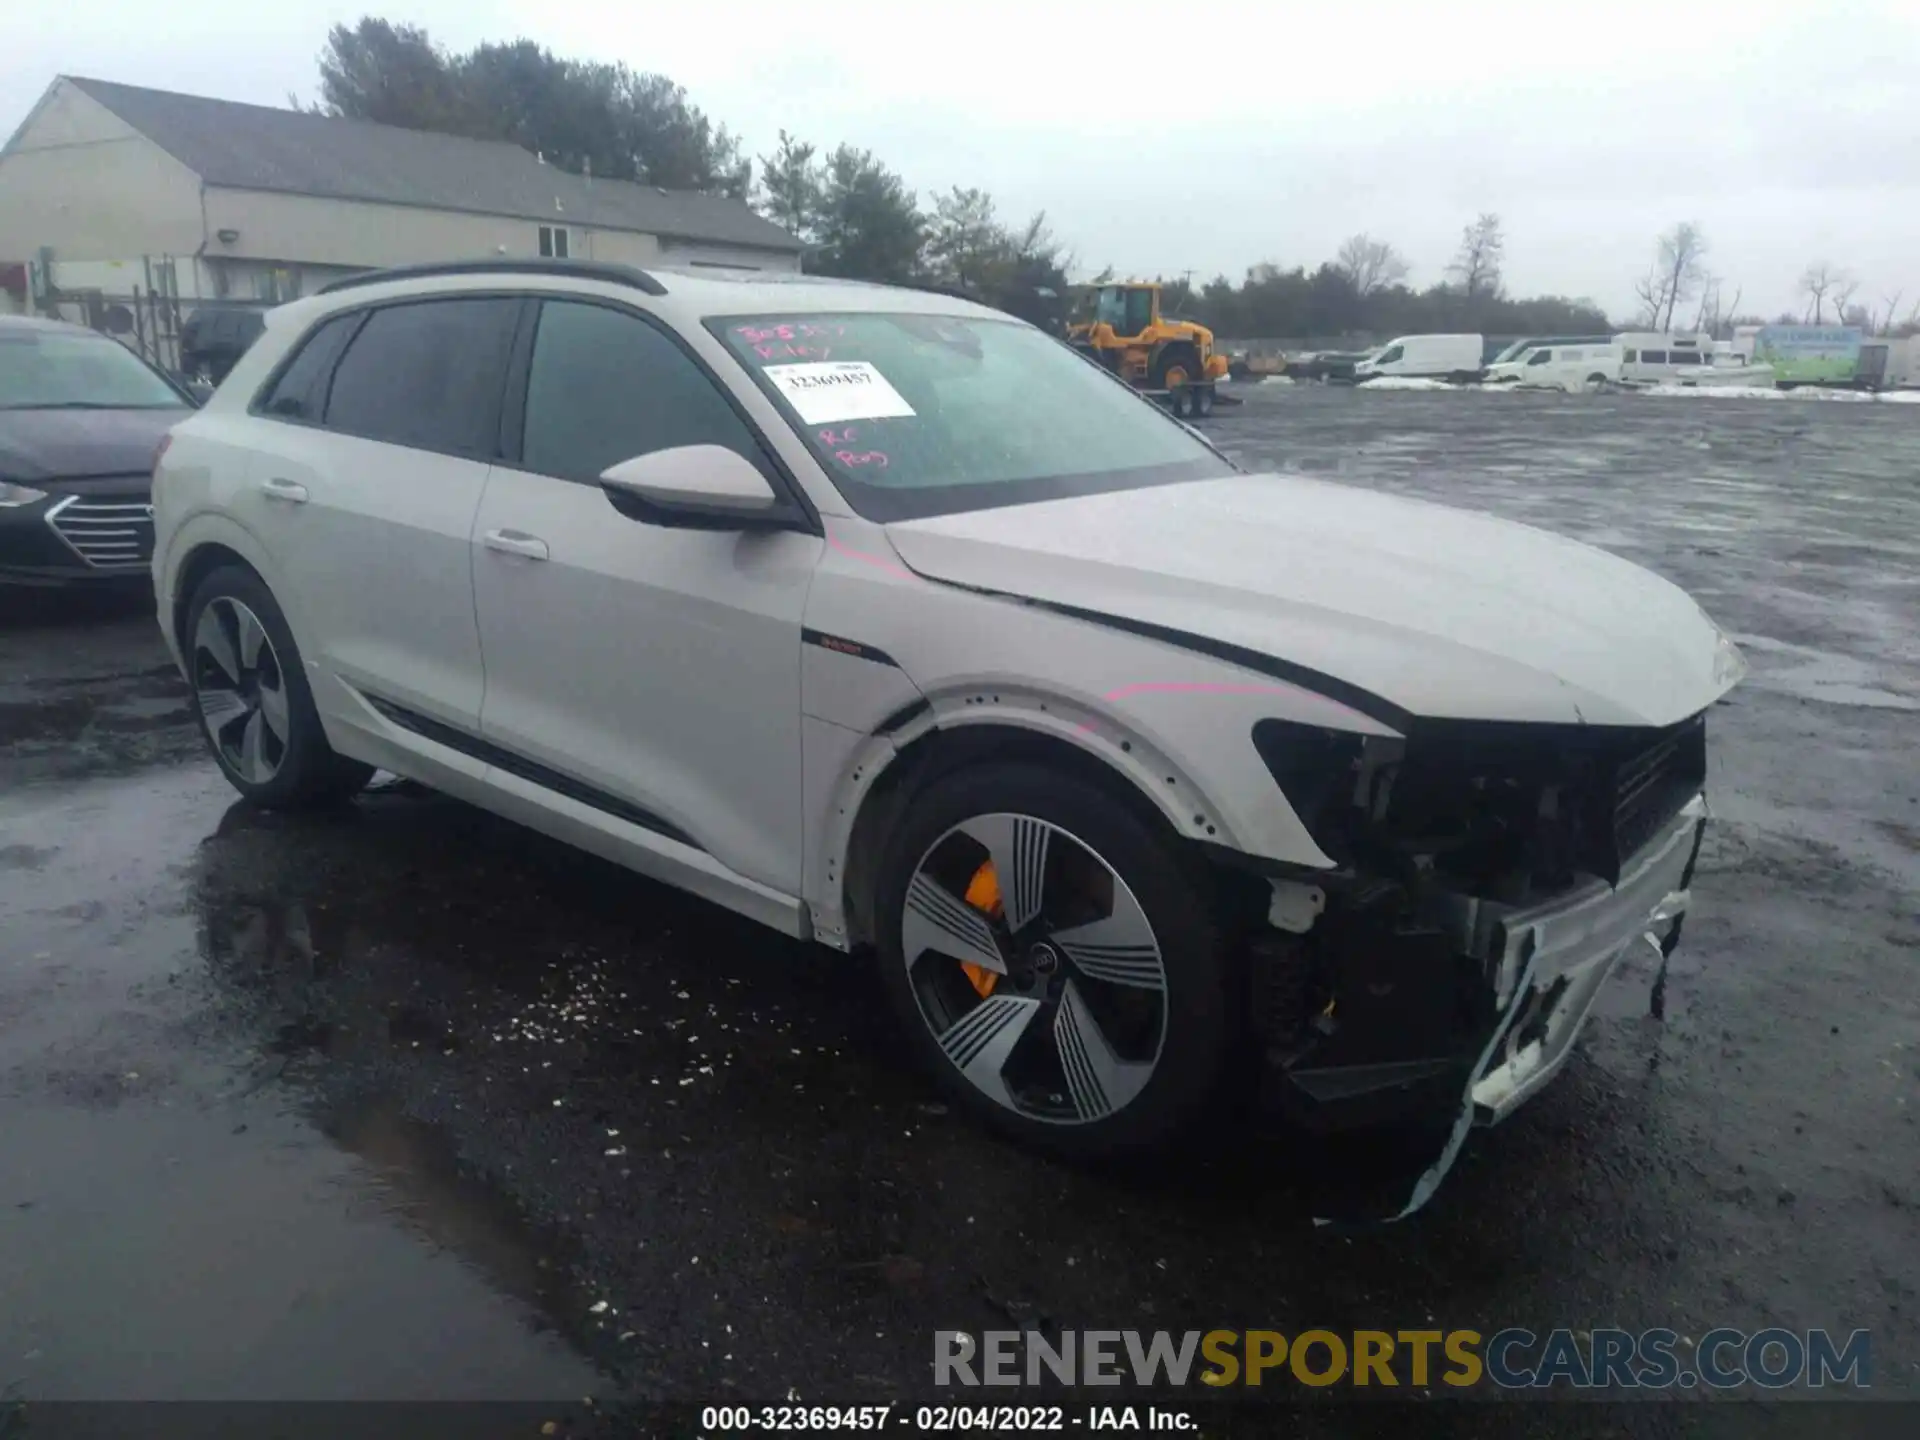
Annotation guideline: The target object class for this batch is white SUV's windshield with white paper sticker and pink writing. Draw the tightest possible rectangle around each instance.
[710,315,1233,520]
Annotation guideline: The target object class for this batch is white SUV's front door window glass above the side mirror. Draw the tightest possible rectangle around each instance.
[520,300,766,480]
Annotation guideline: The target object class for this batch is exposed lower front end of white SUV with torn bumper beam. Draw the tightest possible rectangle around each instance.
[1246,797,1707,1223]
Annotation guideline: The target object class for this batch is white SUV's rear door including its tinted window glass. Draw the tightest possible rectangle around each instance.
[242,296,522,732]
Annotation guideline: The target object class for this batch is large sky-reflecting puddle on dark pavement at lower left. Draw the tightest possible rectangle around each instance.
[0,766,605,1402]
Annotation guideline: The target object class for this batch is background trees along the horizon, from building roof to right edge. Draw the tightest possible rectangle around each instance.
[315,17,1920,338]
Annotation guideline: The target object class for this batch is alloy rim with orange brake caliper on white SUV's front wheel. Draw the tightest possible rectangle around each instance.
[900,814,1167,1125]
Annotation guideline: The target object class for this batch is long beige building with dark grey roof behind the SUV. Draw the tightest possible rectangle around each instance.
[0,77,801,363]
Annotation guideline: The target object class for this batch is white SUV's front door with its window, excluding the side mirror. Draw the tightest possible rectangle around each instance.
[474,300,822,895]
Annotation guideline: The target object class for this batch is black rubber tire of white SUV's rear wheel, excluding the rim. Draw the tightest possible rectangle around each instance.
[180,564,372,810]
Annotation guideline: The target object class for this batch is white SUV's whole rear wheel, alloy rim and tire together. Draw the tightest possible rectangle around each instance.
[182,566,372,808]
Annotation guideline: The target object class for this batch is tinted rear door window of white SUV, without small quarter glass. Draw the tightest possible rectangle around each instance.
[326,298,520,459]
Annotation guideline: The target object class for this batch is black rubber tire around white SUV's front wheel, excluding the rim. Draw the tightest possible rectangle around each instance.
[874,762,1238,1160]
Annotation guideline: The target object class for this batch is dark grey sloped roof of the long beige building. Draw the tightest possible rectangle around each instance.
[65,75,801,252]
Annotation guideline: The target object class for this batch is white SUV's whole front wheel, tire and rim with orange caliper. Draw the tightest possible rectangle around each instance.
[879,766,1227,1154]
